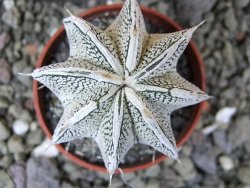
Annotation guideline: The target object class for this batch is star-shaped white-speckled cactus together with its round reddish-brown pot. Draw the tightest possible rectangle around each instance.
[27,0,209,176]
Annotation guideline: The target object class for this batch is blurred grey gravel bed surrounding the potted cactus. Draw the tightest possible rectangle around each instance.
[0,0,250,188]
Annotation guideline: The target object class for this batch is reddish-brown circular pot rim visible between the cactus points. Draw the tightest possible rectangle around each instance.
[33,4,206,173]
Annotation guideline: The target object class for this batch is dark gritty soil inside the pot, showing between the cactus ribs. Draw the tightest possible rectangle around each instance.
[43,11,193,167]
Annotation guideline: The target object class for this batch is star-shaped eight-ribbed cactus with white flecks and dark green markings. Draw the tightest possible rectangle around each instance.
[28,0,209,175]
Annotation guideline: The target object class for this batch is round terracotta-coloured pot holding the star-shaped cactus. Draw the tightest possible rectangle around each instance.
[33,4,206,173]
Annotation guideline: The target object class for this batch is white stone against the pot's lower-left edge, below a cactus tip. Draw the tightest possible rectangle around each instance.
[33,138,59,158]
